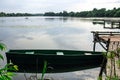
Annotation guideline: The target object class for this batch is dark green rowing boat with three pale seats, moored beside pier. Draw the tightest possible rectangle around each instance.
[6,50,103,73]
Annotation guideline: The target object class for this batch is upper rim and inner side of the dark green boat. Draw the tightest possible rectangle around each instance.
[6,49,103,56]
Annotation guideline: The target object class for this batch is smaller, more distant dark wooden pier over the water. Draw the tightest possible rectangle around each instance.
[93,19,120,29]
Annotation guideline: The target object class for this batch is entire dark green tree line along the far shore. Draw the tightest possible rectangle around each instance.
[0,8,120,17]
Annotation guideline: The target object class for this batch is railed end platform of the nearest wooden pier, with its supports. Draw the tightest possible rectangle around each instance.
[92,31,120,51]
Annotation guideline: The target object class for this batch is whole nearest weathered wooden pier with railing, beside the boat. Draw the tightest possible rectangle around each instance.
[92,31,120,80]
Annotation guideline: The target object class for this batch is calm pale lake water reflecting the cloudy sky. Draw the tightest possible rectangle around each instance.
[0,16,119,80]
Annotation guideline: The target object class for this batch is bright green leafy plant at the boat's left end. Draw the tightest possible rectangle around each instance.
[0,43,18,80]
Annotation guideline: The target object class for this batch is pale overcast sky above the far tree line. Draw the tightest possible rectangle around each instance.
[0,0,120,13]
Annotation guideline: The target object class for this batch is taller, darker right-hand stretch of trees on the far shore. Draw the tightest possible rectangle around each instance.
[44,8,120,17]
